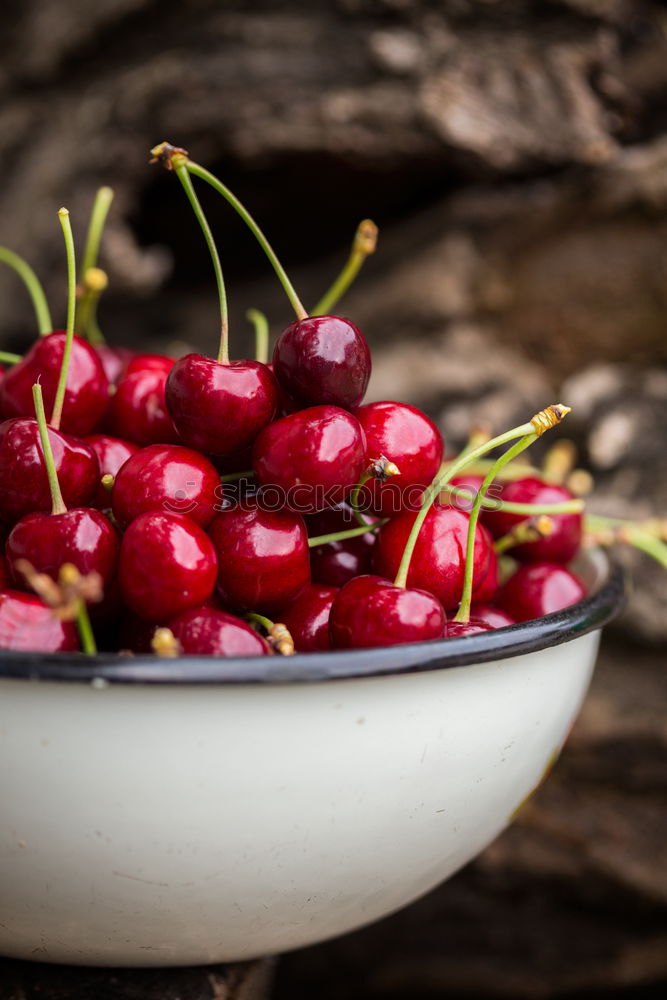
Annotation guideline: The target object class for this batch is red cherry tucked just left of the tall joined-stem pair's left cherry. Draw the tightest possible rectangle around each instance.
[110,354,180,445]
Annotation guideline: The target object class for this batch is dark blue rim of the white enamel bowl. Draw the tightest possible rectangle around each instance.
[0,554,627,686]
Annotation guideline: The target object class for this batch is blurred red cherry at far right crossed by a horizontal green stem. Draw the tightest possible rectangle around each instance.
[484,477,583,563]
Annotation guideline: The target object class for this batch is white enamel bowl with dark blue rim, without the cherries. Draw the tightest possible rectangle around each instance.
[0,554,623,966]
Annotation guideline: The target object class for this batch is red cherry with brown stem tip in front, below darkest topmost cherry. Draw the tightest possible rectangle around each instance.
[354,401,444,517]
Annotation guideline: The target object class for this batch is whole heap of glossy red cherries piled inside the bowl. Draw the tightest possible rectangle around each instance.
[0,144,585,656]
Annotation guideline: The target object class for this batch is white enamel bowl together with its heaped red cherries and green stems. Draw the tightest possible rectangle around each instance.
[0,143,648,966]
